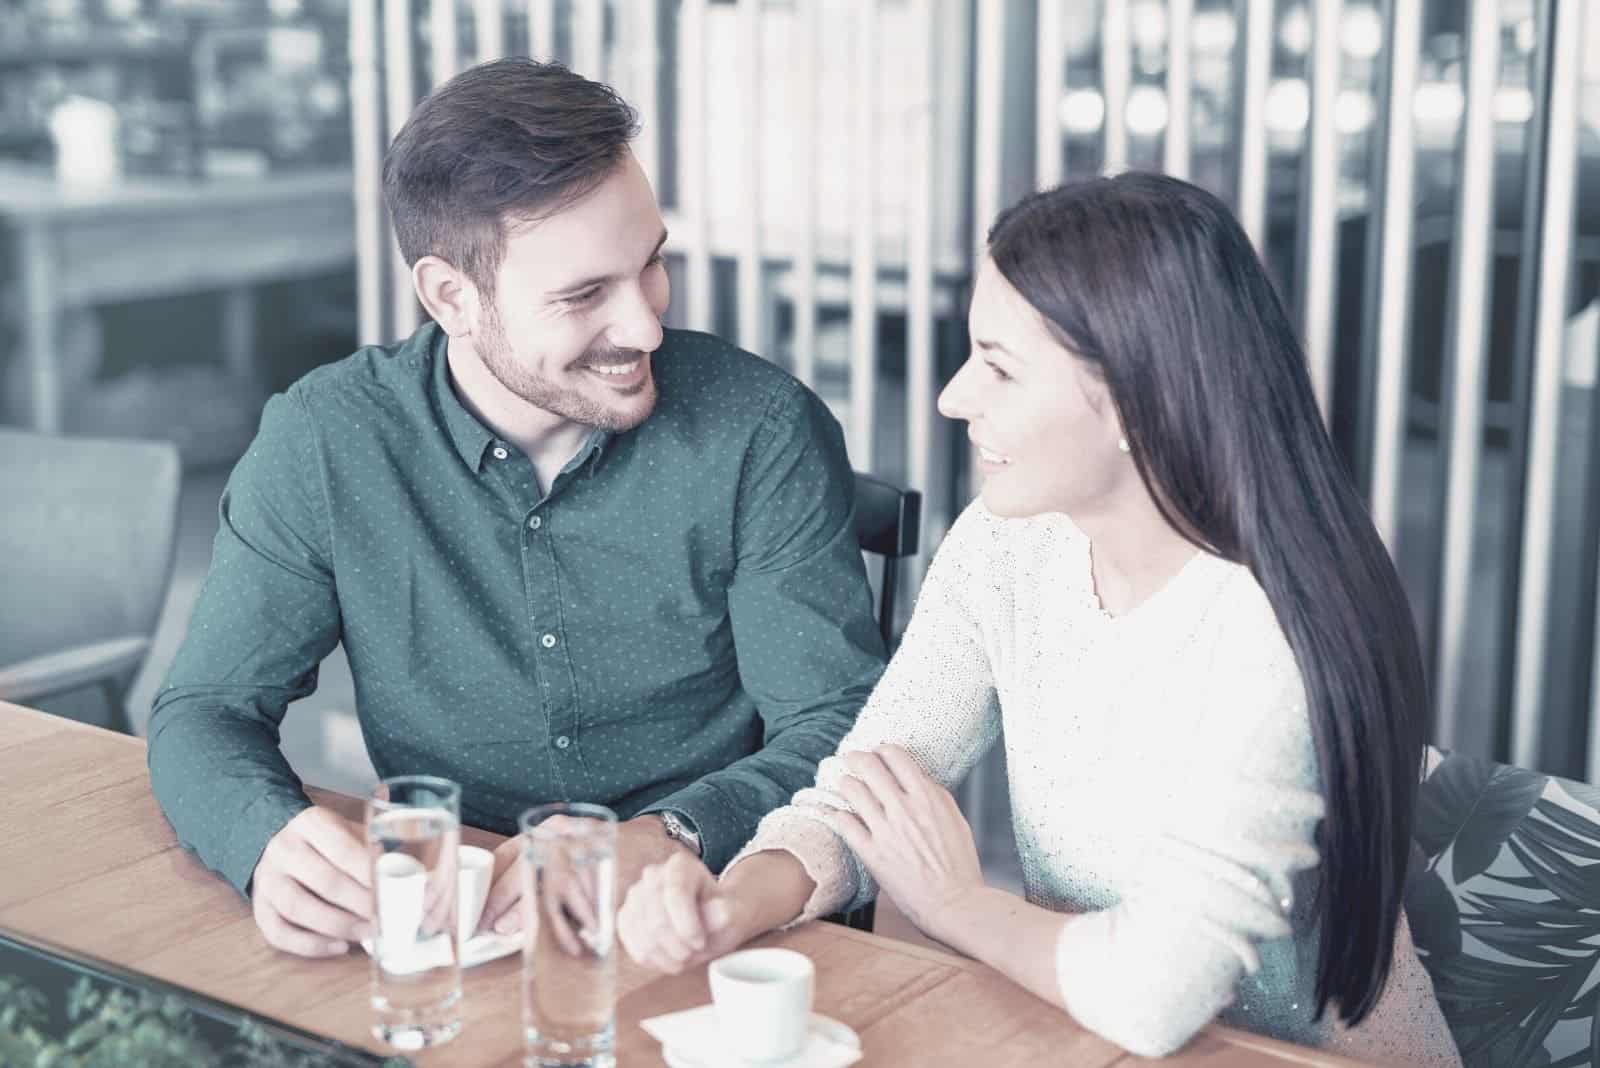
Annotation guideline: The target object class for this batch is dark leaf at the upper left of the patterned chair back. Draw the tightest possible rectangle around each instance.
[1416,753,1546,884]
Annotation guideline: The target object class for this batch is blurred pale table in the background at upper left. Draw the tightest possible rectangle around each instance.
[0,163,355,433]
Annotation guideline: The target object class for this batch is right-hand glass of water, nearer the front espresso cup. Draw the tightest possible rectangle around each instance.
[520,804,616,1068]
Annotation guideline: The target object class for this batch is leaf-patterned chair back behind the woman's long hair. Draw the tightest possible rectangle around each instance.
[1405,748,1600,1068]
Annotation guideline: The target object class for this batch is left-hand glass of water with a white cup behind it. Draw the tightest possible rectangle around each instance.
[366,775,461,1050]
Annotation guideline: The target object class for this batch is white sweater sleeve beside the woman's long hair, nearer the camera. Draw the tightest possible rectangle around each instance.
[1056,601,1323,1057]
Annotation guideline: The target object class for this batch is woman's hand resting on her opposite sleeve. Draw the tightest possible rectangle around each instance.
[822,745,984,945]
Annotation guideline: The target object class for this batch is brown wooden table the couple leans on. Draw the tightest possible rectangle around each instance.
[0,702,1376,1068]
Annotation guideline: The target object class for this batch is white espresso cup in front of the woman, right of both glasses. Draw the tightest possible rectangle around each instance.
[709,950,816,1062]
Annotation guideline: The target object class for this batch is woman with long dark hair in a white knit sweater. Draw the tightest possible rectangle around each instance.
[619,174,1459,1066]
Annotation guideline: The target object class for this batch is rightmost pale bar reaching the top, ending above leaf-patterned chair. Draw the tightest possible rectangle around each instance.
[1512,0,1574,767]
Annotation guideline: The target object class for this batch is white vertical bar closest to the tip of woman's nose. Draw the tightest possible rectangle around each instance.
[906,0,934,500]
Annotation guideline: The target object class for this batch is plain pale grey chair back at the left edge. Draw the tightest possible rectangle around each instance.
[0,428,179,719]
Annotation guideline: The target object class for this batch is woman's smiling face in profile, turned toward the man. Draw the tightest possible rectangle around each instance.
[939,257,1138,516]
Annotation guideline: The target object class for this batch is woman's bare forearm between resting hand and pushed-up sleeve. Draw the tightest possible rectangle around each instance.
[928,886,1074,1006]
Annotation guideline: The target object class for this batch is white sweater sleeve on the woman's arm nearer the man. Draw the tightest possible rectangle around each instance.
[723,504,1000,924]
